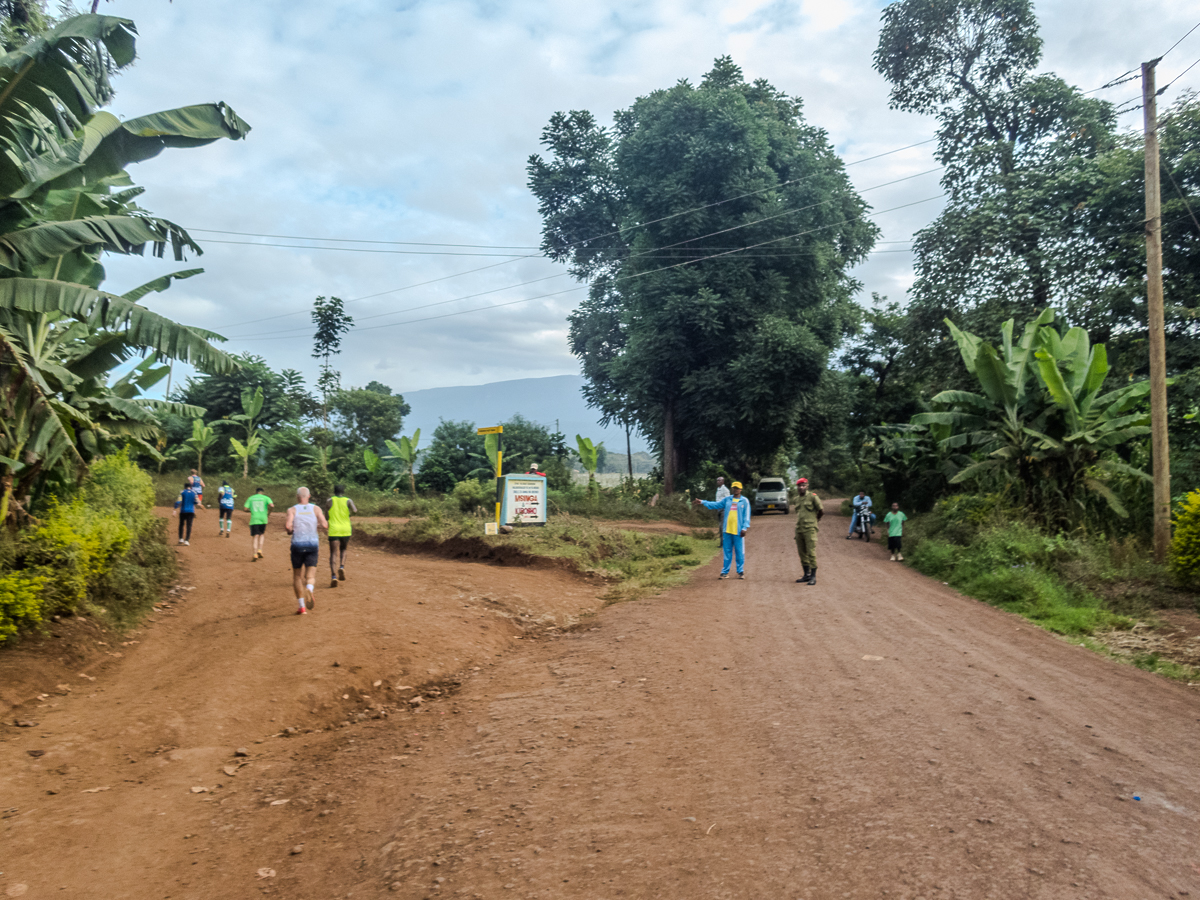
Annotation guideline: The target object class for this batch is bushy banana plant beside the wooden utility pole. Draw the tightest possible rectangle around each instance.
[912,310,1150,527]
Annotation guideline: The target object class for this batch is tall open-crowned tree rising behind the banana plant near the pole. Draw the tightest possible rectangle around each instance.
[875,0,1113,380]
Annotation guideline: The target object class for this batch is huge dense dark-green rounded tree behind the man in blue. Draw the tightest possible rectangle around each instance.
[528,58,877,492]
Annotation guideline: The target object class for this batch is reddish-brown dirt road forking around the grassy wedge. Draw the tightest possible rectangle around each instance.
[0,504,1200,900]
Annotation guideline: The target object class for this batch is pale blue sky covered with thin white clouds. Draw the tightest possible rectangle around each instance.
[101,0,1200,392]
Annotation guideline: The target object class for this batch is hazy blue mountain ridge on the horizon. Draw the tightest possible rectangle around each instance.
[402,376,647,454]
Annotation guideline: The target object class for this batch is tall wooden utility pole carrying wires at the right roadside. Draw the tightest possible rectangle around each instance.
[1141,59,1171,563]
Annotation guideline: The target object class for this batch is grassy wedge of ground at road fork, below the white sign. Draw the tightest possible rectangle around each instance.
[360,514,720,602]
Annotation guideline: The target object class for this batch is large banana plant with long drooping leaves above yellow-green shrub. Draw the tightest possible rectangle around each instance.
[0,10,250,515]
